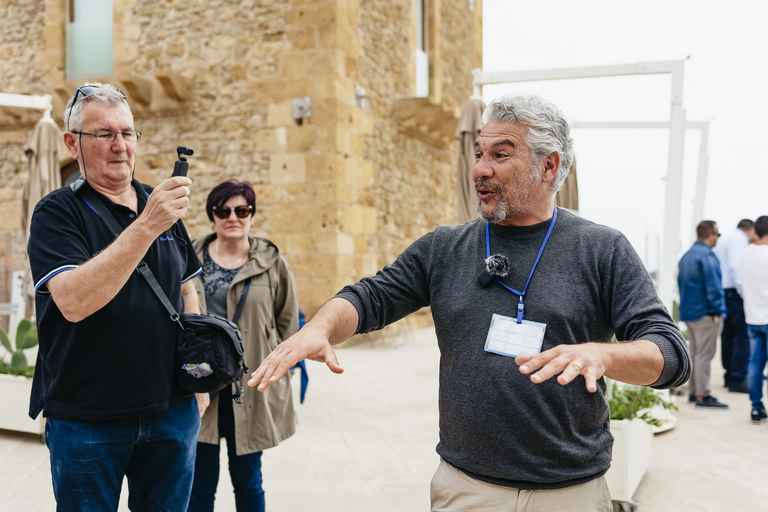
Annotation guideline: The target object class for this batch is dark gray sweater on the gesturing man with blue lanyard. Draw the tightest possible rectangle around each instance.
[337,210,691,489]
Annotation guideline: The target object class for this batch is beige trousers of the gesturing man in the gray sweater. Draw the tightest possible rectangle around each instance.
[430,459,613,512]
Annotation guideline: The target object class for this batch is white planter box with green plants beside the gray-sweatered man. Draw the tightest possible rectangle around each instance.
[605,419,653,502]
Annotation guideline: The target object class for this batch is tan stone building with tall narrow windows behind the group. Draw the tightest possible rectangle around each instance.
[0,0,482,332]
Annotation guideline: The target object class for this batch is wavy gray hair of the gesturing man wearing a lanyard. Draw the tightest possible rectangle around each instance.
[483,94,573,195]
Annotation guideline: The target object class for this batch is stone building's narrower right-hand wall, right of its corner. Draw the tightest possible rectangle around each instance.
[359,0,480,274]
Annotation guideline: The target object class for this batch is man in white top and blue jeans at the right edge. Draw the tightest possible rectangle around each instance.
[741,215,768,423]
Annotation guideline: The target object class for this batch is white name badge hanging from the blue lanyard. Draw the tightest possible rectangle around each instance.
[485,313,547,357]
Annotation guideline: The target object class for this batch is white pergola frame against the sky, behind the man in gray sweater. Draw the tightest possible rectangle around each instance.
[472,59,709,312]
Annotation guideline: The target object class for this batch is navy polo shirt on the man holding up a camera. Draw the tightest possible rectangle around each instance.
[28,180,201,421]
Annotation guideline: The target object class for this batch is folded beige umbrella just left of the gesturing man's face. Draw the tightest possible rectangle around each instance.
[456,100,485,224]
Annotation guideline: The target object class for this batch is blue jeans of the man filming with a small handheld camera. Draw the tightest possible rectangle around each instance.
[45,395,200,512]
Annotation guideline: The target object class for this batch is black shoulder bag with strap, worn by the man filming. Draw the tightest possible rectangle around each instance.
[72,180,251,404]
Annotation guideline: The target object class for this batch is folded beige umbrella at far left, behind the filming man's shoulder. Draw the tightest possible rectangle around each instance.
[21,116,69,315]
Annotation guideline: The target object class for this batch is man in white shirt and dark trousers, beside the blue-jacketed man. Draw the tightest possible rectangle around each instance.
[714,219,755,393]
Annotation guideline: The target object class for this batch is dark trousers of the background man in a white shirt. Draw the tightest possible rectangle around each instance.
[721,288,749,386]
